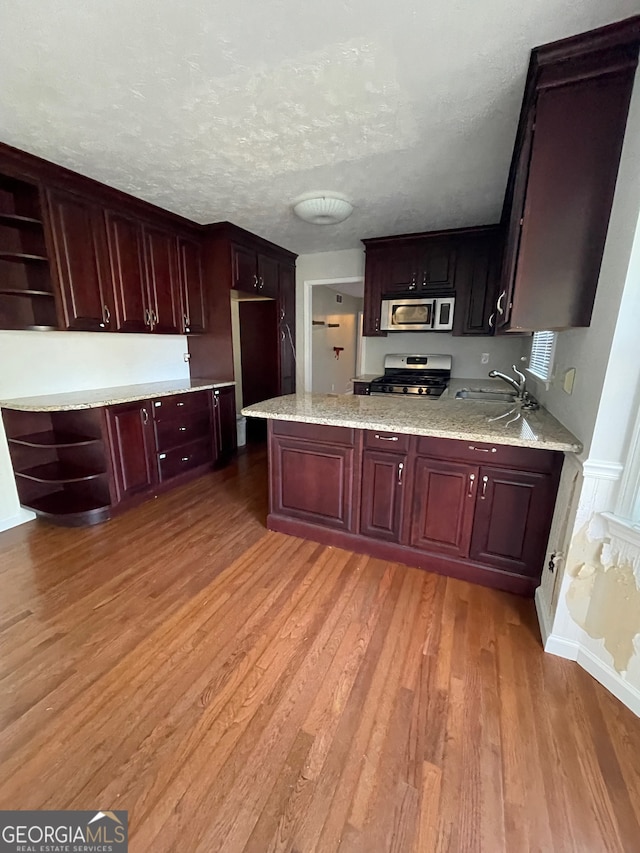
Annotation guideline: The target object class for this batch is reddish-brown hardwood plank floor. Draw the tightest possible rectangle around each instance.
[0,442,640,853]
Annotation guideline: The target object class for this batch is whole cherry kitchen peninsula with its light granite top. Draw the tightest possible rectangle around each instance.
[243,390,582,595]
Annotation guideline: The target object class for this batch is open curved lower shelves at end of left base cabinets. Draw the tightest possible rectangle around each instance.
[2,408,112,527]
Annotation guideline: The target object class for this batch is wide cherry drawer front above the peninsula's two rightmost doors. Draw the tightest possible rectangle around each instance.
[417,436,562,472]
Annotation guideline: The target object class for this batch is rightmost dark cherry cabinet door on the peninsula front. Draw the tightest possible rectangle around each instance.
[470,467,555,577]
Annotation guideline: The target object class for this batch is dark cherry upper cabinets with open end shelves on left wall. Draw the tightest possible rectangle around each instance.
[0,140,206,334]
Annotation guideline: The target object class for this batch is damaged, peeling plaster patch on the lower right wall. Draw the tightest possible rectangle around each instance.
[566,516,640,673]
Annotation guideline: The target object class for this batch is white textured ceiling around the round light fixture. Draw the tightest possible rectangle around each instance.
[0,0,639,252]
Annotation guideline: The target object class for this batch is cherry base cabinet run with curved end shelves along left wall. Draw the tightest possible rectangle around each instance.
[2,386,236,526]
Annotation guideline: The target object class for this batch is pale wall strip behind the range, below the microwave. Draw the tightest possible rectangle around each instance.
[362,332,531,379]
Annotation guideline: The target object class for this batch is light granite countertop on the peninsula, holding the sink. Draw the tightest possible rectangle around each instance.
[242,379,582,453]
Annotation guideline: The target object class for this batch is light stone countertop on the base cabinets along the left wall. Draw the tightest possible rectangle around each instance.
[0,378,236,412]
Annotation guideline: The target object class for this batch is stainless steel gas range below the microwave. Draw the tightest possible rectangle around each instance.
[371,354,451,399]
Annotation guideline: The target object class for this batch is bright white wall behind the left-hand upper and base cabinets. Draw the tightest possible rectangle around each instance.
[0,332,189,530]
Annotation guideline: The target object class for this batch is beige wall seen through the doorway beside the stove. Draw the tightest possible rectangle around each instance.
[311,284,363,394]
